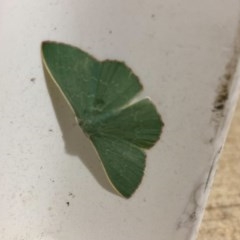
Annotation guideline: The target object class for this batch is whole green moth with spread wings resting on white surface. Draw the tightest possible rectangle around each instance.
[42,41,163,198]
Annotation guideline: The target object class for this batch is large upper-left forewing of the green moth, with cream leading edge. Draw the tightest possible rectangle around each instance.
[42,41,100,118]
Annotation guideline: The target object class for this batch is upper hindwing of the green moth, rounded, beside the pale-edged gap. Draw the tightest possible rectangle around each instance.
[94,60,142,112]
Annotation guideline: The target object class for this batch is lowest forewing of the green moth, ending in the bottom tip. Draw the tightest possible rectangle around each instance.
[91,136,146,198]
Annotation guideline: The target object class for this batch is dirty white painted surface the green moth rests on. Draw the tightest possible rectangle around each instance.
[0,0,239,240]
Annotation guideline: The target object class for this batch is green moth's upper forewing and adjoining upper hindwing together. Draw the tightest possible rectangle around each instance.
[42,41,142,119]
